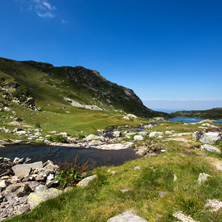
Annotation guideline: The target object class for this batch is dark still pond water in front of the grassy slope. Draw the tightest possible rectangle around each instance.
[0,145,140,169]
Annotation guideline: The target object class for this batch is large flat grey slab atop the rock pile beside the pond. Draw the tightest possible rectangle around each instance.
[12,161,43,178]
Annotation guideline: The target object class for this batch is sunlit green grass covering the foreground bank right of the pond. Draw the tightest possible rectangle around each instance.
[4,136,222,222]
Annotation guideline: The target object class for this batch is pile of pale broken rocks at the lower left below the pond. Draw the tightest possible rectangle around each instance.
[0,157,59,221]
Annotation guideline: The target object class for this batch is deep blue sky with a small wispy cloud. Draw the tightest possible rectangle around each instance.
[0,0,222,109]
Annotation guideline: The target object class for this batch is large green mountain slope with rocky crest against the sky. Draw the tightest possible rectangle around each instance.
[0,58,168,118]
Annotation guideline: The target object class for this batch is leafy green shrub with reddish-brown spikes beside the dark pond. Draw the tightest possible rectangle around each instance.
[55,155,88,189]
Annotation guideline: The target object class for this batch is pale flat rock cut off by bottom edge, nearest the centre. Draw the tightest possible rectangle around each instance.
[107,210,146,222]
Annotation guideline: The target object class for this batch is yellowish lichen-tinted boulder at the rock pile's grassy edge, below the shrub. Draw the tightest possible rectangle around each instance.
[28,188,62,209]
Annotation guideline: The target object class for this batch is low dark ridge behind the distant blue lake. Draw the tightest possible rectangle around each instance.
[171,108,222,119]
